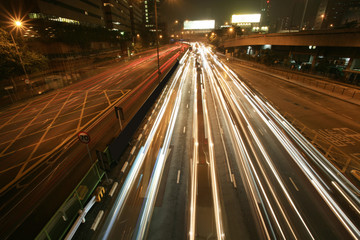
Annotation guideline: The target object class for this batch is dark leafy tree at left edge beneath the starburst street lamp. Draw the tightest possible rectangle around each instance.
[0,28,47,81]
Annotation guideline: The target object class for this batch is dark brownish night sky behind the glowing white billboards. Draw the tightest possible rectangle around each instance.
[162,0,321,25]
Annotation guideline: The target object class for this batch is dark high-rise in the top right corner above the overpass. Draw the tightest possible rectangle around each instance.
[314,0,360,30]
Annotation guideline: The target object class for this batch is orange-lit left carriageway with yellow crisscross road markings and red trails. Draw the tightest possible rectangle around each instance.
[0,44,181,239]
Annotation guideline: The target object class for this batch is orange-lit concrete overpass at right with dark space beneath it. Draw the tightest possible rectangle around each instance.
[224,29,360,74]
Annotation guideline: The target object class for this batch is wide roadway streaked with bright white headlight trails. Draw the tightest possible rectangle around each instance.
[98,43,360,239]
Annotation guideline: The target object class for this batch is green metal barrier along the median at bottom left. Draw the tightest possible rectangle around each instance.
[35,161,105,240]
